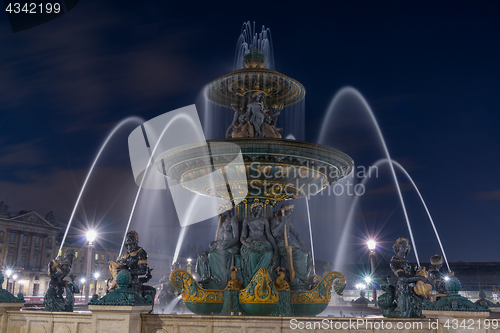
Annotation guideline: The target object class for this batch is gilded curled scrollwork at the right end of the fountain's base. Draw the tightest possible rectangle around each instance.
[291,272,346,304]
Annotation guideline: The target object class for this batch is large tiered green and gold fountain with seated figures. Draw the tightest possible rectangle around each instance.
[148,27,354,316]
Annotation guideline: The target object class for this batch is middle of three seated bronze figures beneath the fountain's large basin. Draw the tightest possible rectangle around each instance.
[240,202,278,285]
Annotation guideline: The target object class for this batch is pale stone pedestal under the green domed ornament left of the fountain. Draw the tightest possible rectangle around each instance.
[89,305,151,333]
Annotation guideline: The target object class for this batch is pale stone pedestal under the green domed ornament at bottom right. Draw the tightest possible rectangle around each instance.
[422,310,491,333]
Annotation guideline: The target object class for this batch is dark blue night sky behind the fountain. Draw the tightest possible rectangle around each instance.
[0,0,500,262]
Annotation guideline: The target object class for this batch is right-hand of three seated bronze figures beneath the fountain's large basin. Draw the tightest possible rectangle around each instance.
[271,205,312,285]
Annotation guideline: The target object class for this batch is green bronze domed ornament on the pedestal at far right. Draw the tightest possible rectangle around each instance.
[425,276,491,312]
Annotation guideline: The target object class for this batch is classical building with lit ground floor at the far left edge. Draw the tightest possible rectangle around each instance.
[0,202,60,296]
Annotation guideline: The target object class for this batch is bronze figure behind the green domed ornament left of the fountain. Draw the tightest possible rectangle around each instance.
[109,230,156,299]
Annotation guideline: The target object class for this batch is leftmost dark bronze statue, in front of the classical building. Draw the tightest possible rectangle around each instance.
[43,249,80,312]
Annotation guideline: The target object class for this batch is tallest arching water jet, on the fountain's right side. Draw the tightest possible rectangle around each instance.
[318,87,420,266]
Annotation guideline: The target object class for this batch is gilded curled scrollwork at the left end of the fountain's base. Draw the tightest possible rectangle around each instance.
[170,269,224,303]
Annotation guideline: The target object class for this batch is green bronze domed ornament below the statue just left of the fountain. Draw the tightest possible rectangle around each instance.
[89,269,153,306]
